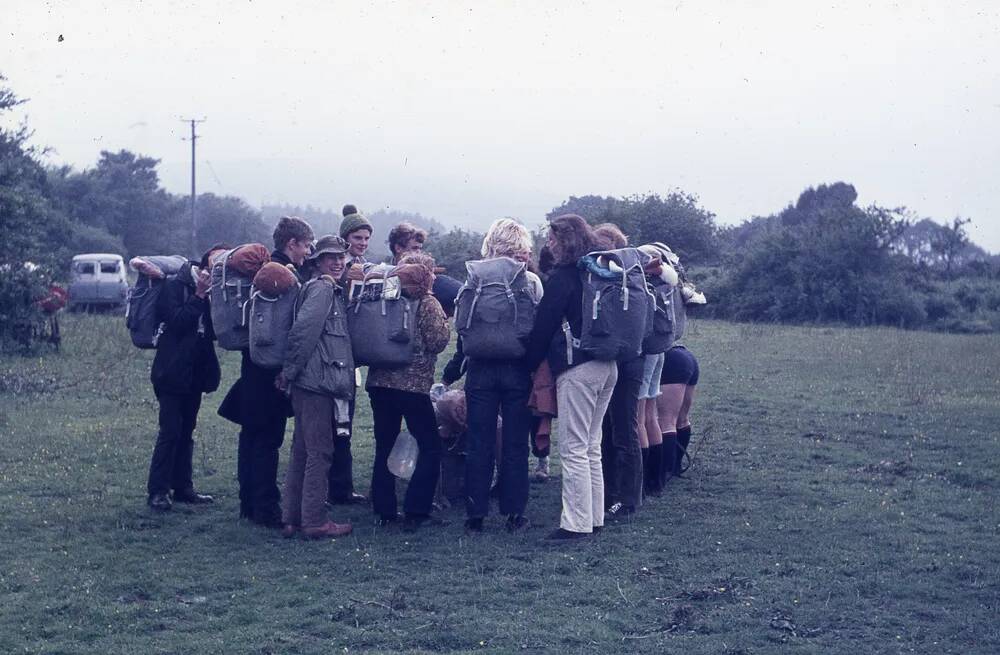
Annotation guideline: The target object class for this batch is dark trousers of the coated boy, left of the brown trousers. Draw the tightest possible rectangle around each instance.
[236,416,287,522]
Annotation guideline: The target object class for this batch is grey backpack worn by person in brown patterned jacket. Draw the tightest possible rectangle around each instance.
[347,267,420,368]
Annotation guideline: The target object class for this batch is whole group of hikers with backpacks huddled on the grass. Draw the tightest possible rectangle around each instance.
[139,205,704,543]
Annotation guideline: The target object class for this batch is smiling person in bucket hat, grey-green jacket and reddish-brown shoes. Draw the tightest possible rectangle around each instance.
[275,235,354,538]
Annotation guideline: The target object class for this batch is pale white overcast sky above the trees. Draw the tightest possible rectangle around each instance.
[0,0,1000,252]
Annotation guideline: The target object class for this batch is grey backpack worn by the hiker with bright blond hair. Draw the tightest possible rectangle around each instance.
[455,257,535,359]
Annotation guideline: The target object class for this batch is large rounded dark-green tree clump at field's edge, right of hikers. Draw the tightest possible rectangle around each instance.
[716,183,922,325]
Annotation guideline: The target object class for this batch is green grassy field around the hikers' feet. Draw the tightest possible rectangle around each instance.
[0,316,1000,655]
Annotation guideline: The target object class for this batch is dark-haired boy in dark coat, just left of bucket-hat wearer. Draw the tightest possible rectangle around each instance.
[219,216,314,528]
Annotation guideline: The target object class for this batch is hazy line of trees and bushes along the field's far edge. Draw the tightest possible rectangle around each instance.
[0,75,1000,347]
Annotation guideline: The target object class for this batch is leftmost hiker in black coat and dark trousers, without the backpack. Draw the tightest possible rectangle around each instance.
[146,247,224,511]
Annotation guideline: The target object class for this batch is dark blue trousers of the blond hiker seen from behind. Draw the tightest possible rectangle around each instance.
[465,360,531,518]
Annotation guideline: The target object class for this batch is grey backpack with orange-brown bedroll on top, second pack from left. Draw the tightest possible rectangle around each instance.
[209,243,269,350]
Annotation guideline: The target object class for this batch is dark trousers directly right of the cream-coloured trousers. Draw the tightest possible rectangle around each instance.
[601,357,643,507]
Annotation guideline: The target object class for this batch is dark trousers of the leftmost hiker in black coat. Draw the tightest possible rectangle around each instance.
[146,392,201,496]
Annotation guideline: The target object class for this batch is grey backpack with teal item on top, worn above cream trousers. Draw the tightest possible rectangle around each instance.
[578,248,654,361]
